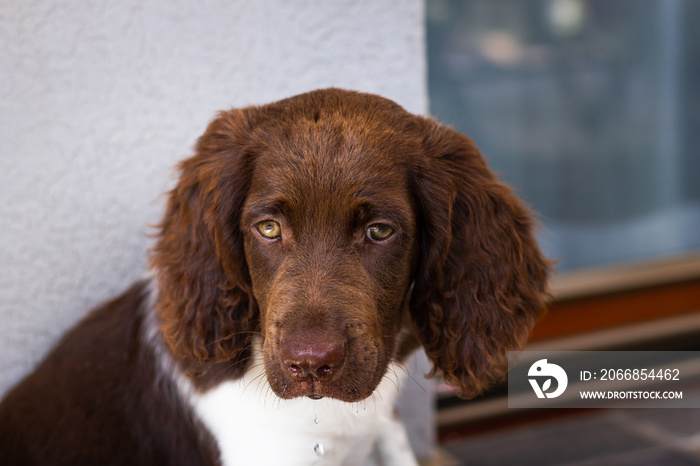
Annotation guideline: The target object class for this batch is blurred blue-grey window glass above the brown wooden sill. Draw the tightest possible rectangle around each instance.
[427,0,700,270]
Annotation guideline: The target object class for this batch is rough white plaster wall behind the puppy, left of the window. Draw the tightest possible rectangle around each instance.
[0,0,427,456]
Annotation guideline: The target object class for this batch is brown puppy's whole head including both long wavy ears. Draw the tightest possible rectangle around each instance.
[151,89,548,401]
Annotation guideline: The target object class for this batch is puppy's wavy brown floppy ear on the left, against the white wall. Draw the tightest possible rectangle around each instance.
[151,109,258,374]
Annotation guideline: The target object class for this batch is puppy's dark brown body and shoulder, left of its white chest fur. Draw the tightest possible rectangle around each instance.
[0,281,215,464]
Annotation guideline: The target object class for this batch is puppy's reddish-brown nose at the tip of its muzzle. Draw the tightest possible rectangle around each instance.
[280,337,345,380]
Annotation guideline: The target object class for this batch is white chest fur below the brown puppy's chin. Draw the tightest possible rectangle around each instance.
[190,354,416,466]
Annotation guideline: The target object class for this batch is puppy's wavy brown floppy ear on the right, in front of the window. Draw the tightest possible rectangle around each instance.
[411,120,550,398]
